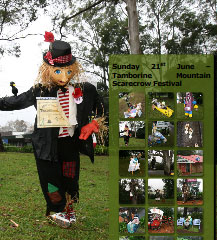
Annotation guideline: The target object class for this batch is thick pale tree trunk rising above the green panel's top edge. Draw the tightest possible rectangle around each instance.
[125,0,141,54]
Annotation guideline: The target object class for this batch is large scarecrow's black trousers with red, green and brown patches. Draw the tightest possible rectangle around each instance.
[36,134,80,214]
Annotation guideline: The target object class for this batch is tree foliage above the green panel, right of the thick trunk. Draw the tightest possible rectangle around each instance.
[141,0,217,54]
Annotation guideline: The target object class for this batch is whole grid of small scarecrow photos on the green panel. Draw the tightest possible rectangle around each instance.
[118,91,204,240]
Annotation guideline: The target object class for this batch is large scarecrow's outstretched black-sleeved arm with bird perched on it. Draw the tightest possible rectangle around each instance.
[0,87,36,111]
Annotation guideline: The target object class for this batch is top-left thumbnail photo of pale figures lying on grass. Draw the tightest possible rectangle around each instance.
[119,92,145,118]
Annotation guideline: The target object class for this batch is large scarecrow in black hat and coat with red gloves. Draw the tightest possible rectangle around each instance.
[0,32,103,228]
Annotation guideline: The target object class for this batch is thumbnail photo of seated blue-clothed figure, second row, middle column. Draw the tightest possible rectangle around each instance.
[148,121,174,147]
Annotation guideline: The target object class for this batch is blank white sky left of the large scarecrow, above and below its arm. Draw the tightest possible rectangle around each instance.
[0,16,52,126]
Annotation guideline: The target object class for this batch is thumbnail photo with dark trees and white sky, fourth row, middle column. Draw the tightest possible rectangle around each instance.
[148,178,174,204]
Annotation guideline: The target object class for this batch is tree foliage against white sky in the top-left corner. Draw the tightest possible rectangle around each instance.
[0,0,47,57]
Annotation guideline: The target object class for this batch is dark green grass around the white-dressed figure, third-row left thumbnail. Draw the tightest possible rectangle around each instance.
[119,157,145,177]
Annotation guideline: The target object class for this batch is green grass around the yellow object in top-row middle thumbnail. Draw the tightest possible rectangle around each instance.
[148,98,175,119]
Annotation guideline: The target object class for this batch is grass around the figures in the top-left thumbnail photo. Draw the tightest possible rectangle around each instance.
[119,92,145,118]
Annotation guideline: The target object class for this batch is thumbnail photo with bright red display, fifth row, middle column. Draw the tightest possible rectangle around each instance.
[148,207,174,233]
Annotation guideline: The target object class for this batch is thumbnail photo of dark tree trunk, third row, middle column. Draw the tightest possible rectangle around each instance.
[148,150,174,176]
